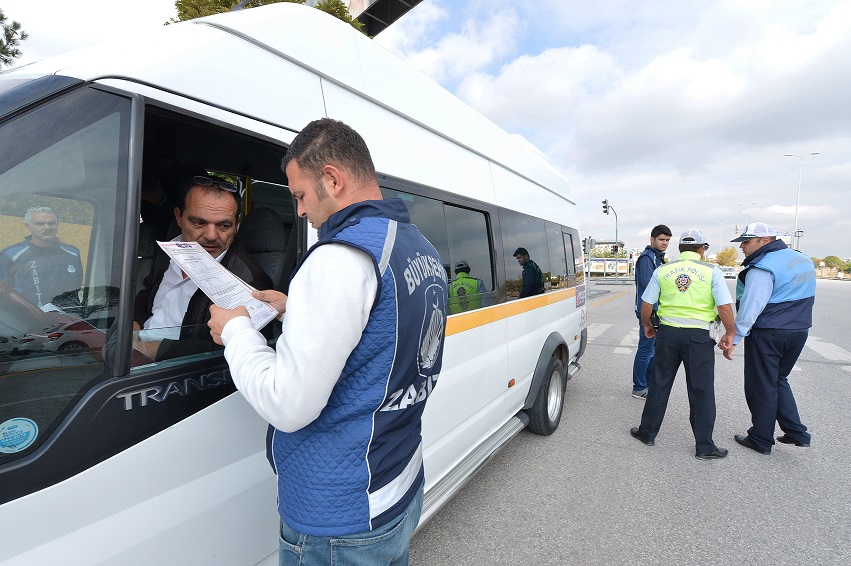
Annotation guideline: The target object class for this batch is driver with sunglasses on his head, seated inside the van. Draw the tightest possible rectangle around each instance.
[133,175,272,360]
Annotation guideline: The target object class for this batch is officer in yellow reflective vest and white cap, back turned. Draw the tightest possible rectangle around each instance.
[630,229,736,460]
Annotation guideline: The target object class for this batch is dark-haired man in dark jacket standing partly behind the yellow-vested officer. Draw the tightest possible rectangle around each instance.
[632,224,671,399]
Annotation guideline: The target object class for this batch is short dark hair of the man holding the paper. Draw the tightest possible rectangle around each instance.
[281,118,376,181]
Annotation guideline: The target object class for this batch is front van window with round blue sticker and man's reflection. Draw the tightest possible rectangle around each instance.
[0,88,130,465]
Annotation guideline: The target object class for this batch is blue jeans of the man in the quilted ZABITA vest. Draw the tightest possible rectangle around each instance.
[278,486,423,566]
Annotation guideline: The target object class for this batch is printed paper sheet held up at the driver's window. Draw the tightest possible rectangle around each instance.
[157,242,279,330]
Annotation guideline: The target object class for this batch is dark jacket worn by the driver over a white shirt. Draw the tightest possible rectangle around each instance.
[133,236,272,360]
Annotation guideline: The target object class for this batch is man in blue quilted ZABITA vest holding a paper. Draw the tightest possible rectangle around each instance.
[209,118,447,566]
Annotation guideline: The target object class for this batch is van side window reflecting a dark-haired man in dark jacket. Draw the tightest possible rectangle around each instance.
[499,209,552,301]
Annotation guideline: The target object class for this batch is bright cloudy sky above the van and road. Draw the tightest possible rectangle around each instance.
[2,0,851,259]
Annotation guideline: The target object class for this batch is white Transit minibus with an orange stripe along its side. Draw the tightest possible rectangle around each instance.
[0,3,586,566]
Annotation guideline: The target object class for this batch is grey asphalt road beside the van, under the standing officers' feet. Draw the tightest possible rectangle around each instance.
[411,280,851,566]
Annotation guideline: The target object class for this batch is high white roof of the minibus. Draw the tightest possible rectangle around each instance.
[10,3,570,204]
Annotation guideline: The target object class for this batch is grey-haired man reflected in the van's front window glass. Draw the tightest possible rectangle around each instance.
[0,206,83,307]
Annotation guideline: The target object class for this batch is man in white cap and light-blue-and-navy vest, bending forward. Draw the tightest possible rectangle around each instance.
[722,222,816,454]
